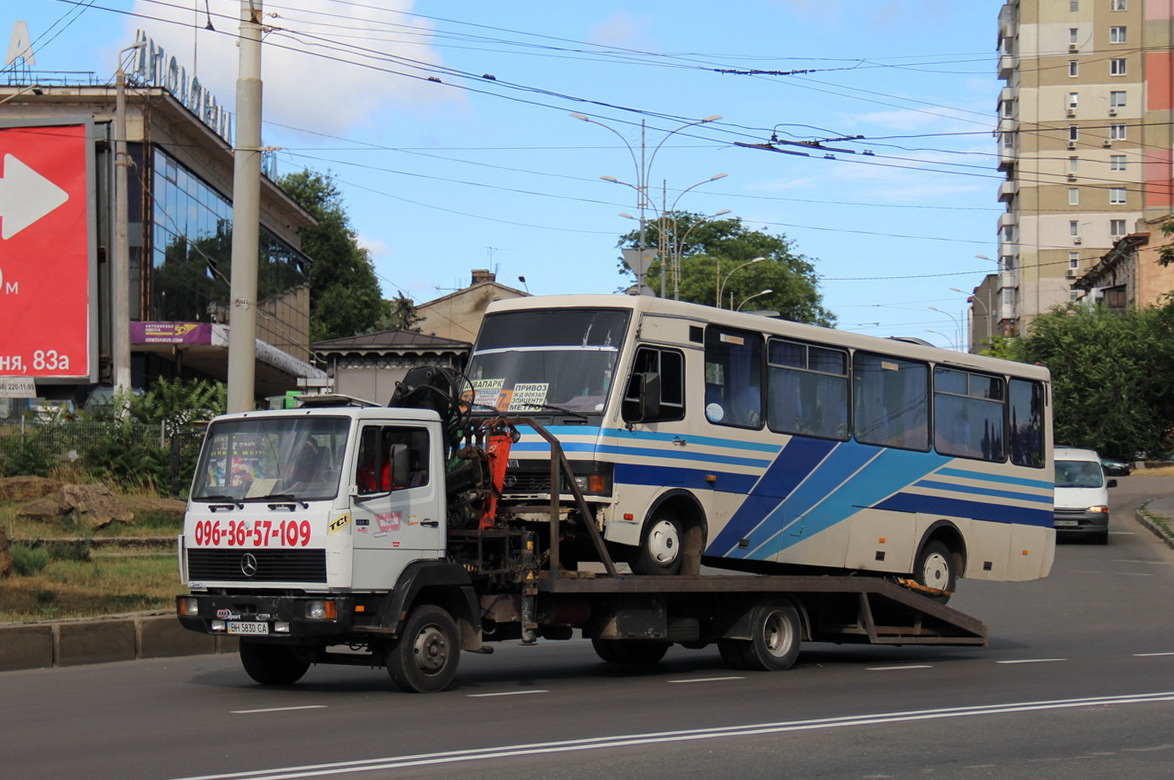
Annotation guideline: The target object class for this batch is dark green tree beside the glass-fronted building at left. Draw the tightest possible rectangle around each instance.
[278,170,390,342]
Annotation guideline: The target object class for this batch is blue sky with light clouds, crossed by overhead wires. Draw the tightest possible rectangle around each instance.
[0,0,1003,347]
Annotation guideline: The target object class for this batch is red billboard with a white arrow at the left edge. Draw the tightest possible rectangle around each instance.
[0,121,95,382]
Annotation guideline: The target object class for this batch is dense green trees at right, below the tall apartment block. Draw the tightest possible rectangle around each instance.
[1000,302,1174,458]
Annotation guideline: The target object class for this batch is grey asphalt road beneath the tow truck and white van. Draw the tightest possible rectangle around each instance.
[0,477,1174,780]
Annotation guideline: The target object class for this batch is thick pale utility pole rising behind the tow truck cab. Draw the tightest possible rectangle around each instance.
[228,0,262,412]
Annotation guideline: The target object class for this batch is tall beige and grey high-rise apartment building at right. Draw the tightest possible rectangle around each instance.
[995,0,1174,336]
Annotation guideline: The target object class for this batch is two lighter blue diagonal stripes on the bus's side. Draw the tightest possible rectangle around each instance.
[728,444,945,560]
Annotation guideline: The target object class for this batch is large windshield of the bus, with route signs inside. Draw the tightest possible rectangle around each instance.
[466,309,629,415]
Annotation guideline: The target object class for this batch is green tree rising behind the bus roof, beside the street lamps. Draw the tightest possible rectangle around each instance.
[619,211,835,325]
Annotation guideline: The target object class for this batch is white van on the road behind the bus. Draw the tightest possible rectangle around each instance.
[1053,446,1116,544]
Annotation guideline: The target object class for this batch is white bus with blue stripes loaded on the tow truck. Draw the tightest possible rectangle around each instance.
[466,295,1055,594]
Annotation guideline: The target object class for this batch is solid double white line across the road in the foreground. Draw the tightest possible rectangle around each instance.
[167,691,1174,780]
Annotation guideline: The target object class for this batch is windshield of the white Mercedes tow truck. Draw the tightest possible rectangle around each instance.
[191,417,350,502]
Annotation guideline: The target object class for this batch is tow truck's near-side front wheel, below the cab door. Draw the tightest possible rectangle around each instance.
[386,604,460,693]
